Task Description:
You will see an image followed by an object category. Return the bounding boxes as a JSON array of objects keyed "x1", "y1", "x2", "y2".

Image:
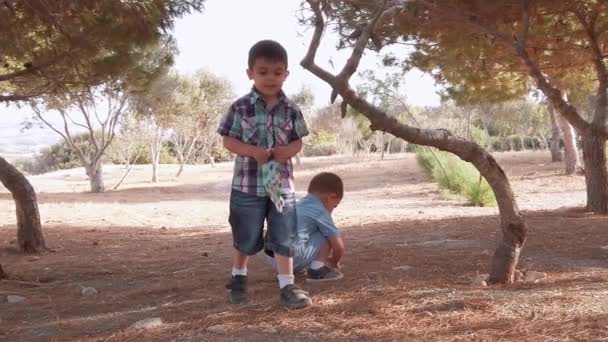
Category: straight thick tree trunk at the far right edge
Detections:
[{"x1": 583, "y1": 130, "x2": 608, "y2": 214}]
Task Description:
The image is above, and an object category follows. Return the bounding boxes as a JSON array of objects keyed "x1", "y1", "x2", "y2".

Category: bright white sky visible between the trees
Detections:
[{"x1": 0, "y1": 0, "x2": 439, "y2": 153}]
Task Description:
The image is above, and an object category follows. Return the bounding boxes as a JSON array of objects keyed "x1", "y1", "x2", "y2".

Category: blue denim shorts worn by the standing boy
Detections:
[{"x1": 229, "y1": 189, "x2": 296, "y2": 257}]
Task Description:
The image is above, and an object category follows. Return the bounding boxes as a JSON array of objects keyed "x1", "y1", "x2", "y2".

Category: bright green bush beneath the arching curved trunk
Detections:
[{"x1": 416, "y1": 148, "x2": 496, "y2": 207}]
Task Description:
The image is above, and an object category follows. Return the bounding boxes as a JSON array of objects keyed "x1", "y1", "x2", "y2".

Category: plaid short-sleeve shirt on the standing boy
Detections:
[{"x1": 217, "y1": 88, "x2": 308, "y2": 197}]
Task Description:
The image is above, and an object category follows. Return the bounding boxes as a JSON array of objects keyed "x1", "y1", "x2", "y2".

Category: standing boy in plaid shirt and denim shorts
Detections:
[{"x1": 218, "y1": 40, "x2": 312, "y2": 308}]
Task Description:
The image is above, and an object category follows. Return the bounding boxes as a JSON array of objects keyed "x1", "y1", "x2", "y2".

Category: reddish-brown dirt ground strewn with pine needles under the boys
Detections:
[{"x1": 0, "y1": 152, "x2": 608, "y2": 341}]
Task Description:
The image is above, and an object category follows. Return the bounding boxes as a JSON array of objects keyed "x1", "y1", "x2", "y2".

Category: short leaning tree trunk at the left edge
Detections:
[{"x1": 0, "y1": 157, "x2": 46, "y2": 253}]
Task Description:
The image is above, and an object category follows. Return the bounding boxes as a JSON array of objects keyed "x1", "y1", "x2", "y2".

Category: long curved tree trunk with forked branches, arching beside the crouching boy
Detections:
[{"x1": 300, "y1": 0, "x2": 527, "y2": 283}]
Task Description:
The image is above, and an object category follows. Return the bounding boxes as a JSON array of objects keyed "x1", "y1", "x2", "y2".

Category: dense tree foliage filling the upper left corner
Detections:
[{"x1": 0, "y1": 0, "x2": 204, "y2": 102}]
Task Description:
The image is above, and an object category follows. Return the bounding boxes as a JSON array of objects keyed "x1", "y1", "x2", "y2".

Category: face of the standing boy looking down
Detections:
[{"x1": 247, "y1": 58, "x2": 289, "y2": 98}]
